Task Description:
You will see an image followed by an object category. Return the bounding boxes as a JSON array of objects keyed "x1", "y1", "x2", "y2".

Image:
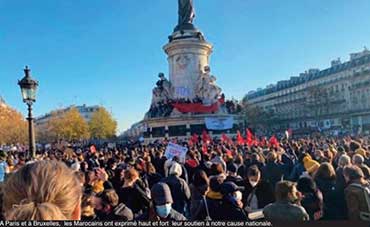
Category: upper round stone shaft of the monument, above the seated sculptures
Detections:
[{"x1": 163, "y1": 30, "x2": 212, "y2": 100}]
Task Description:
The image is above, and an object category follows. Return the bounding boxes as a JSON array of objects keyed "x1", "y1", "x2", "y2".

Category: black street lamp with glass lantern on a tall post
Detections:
[{"x1": 18, "y1": 66, "x2": 39, "y2": 158}]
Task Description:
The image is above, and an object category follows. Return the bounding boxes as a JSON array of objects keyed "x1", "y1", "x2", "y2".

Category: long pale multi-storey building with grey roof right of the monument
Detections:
[{"x1": 244, "y1": 48, "x2": 370, "y2": 133}]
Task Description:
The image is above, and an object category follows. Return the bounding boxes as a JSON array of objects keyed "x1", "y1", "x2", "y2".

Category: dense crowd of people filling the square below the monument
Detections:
[{"x1": 0, "y1": 137, "x2": 370, "y2": 222}]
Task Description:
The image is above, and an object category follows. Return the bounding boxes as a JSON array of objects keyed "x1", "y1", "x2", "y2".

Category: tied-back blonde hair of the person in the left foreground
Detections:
[{"x1": 3, "y1": 161, "x2": 82, "y2": 220}]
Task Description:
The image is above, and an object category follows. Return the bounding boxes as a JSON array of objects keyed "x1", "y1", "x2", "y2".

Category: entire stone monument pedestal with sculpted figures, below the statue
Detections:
[{"x1": 129, "y1": 23, "x2": 241, "y2": 143}]
